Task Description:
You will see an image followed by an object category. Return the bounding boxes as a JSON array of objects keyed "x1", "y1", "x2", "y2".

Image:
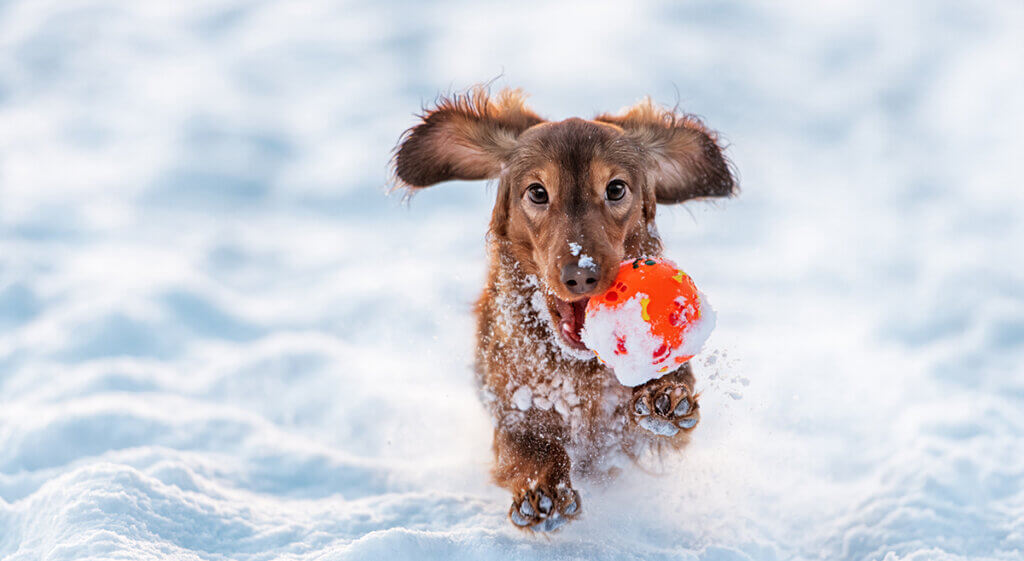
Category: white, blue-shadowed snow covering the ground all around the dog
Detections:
[{"x1": 0, "y1": 0, "x2": 1024, "y2": 561}]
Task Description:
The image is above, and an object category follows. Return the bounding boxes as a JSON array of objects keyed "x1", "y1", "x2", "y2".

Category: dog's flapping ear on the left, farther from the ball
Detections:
[{"x1": 393, "y1": 87, "x2": 544, "y2": 190}]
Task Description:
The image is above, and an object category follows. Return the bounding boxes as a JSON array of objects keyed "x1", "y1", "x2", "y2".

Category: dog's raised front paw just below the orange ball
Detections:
[{"x1": 630, "y1": 380, "x2": 700, "y2": 437}]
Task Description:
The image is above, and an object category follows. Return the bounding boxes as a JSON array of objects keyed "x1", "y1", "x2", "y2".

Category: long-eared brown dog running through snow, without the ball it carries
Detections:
[{"x1": 394, "y1": 88, "x2": 735, "y2": 531}]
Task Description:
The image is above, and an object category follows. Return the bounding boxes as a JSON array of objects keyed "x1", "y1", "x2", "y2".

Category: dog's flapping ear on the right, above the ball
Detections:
[{"x1": 595, "y1": 98, "x2": 737, "y2": 204}]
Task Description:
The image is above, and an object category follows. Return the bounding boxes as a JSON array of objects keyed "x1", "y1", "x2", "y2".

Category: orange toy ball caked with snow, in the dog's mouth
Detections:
[{"x1": 581, "y1": 259, "x2": 715, "y2": 386}]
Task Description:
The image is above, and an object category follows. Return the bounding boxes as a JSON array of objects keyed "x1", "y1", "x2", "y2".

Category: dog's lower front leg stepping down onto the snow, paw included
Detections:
[{"x1": 494, "y1": 428, "x2": 581, "y2": 531}]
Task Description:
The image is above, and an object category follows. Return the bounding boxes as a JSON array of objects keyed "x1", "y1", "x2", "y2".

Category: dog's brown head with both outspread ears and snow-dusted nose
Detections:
[{"x1": 394, "y1": 89, "x2": 735, "y2": 349}]
